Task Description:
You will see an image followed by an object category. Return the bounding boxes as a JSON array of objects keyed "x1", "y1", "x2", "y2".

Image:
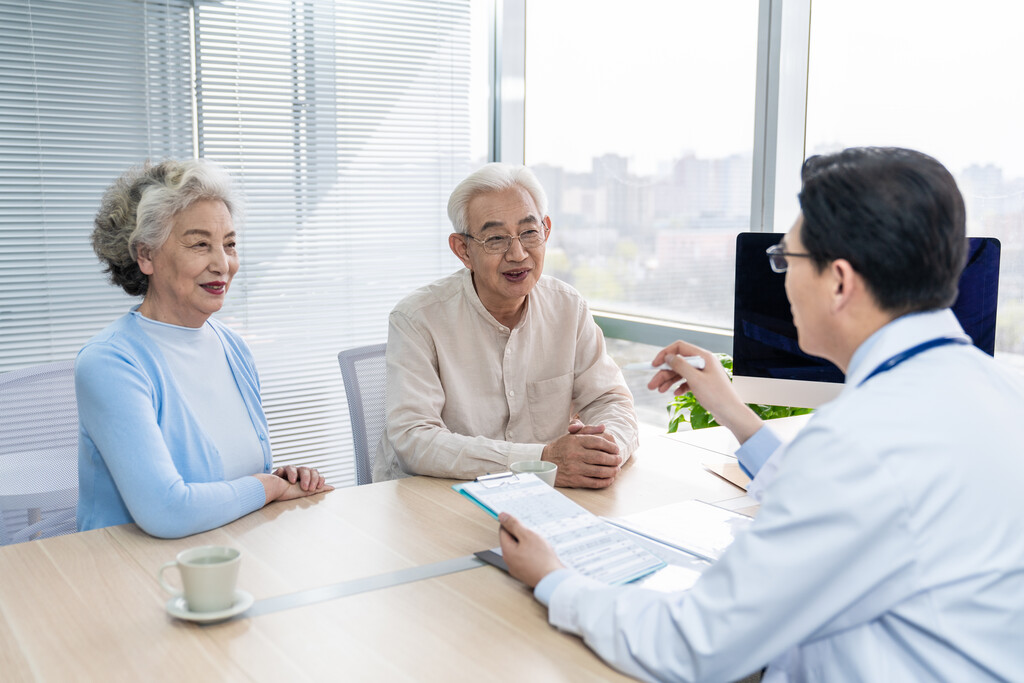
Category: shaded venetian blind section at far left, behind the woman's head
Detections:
[{"x1": 0, "y1": 0, "x2": 193, "y2": 372}]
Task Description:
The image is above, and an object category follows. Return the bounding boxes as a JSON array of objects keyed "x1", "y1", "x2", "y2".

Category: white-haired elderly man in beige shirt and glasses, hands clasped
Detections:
[{"x1": 374, "y1": 164, "x2": 637, "y2": 488}]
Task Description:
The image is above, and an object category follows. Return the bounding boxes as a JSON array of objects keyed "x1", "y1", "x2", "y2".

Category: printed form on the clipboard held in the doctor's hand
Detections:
[{"x1": 453, "y1": 472, "x2": 665, "y2": 585}]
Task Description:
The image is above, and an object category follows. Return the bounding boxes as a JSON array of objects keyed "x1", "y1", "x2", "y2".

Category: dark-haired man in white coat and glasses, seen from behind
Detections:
[{"x1": 500, "y1": 148, "x2": 1024, "y2": 681}]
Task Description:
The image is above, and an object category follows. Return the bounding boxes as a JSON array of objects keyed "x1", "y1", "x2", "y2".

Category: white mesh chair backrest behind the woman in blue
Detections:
[{"x1": 0, "y1": 360, "x2": 78, "y2": 544}]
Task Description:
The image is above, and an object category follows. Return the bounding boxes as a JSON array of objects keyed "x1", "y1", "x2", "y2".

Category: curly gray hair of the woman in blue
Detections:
[{"x1": 92, "y1": 159, "x2": 242, "y2": 296}]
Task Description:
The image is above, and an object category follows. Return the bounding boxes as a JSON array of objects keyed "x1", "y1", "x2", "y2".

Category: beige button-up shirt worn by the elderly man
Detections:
[{"x1": 374, "y1": 269, "x2": 637, "y2": 481}]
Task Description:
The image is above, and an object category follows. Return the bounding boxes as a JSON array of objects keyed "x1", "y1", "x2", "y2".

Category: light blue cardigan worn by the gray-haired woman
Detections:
[{"x1": 75, "y1": 306, "x2": 271, "y2": 539}]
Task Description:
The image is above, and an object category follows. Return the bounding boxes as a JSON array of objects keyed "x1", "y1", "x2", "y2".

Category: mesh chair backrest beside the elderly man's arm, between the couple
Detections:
[{"x1": 338, "y1": 344, "x2": 387, "y2": 484}]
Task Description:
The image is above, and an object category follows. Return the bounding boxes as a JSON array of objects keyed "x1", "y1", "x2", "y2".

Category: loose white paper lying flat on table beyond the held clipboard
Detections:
[{"x1": 608, "y1": 501, "x2": 753, "y2": 562}]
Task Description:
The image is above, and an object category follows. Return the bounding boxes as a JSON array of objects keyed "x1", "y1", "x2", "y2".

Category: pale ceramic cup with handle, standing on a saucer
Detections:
[{"x1": 157, "y1": 546, "x2": 242, "y2": 612}]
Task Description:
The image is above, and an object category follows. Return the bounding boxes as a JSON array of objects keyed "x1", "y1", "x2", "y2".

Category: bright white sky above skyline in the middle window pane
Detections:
[{"x1": 526, "y1": 0, "x2": 758, "y2": 173}]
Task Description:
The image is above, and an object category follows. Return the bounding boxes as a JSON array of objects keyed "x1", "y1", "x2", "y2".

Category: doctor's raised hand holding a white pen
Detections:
[{"x1": 647, "y1": 341, "x2": 764, "y2": 443}]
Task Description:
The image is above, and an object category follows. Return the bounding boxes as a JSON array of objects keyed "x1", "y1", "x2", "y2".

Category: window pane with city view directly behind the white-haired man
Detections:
[{"x1": 525, "y1": 0, "x2": 759, "y2": 328}]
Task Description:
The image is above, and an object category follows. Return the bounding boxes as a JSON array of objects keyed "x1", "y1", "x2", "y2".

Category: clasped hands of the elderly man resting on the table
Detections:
[{"x1": 541, "y1": 420, "x2": 623, "y2": 488}]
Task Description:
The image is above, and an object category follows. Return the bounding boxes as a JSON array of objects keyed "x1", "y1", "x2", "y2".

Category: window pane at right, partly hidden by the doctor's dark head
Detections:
[{"x1": 806, "y1": 0, "x2": 1024, "y2": 360}]
